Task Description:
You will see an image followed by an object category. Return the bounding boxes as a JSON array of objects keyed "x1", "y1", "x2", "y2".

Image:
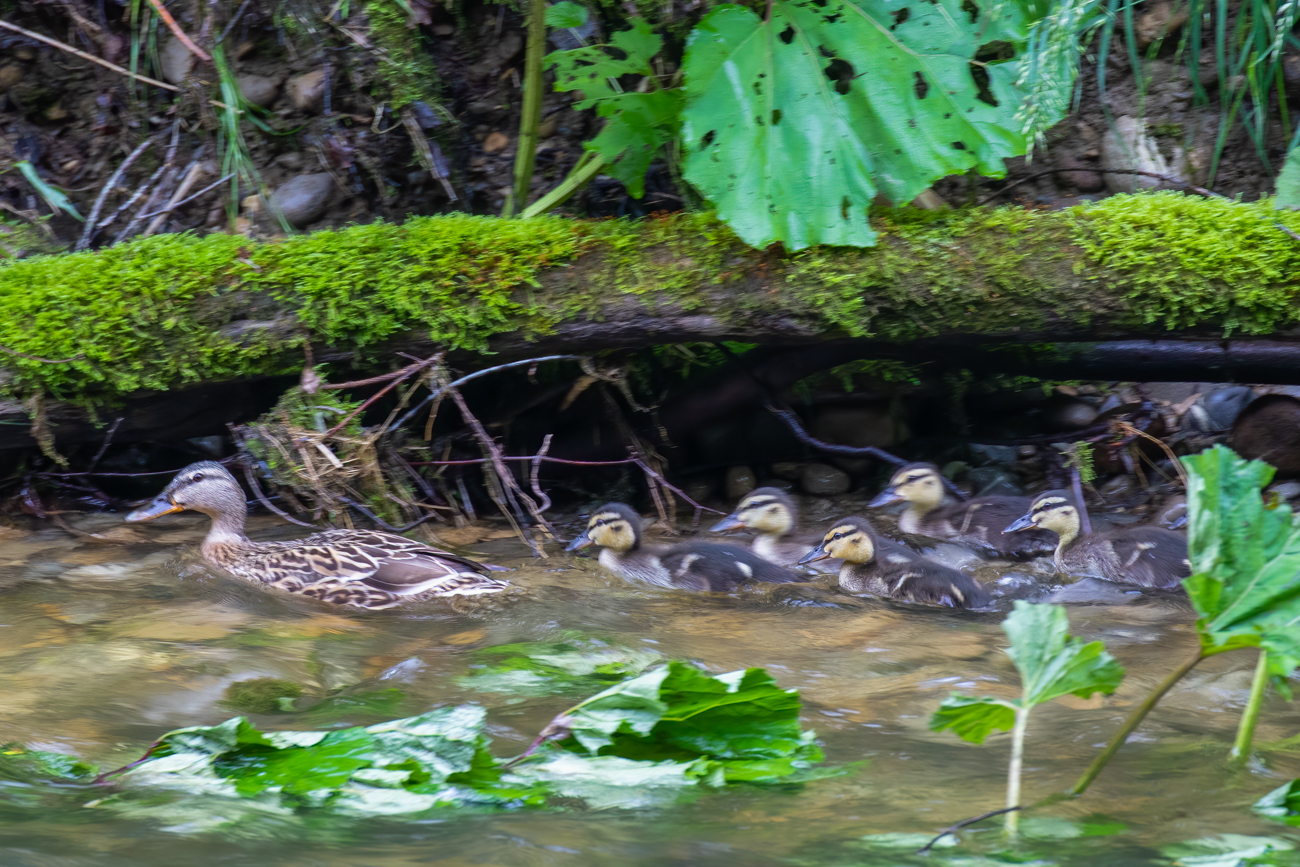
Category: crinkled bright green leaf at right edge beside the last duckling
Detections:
[{"x1": 1183, "y1": 446, "x2": 1300, "y2": 676}]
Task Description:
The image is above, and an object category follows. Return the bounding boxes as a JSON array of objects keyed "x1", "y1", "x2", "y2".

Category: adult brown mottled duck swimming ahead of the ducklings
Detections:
[{"x1": 126, "y1": 460, "x2": 510, "y2": 608}]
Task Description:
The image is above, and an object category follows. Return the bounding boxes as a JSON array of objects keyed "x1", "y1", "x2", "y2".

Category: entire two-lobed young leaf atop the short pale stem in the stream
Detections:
[{"x1": 930, "y1": 608, "x2": 1125, "y2": 744}]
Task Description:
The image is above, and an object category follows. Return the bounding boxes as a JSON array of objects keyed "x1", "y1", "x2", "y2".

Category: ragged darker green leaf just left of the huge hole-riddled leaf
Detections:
[{"x1": 546, "y1": 19, "x2": 681, "y2": 199}]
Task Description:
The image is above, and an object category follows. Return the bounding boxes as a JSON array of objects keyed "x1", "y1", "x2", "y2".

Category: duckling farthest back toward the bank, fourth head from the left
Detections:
[{"x1": 867, "y1": 463, "x2": 1056, "y2": 560}]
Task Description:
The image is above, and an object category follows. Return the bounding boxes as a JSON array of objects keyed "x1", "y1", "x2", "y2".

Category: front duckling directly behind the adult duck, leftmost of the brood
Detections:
[{"x1": 564, "y1": 503, "x2": 807, "y2": 591}]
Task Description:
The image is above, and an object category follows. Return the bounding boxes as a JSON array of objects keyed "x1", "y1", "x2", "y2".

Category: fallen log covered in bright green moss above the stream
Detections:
[{"x1": 0, "y1": 194, "x2": 1300, "y2": 445}]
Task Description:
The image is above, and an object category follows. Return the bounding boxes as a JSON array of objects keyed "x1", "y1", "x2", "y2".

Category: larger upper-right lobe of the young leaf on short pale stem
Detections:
[{"x1": 1002, "y1": 599, "x2": 1125, "y2": 707}]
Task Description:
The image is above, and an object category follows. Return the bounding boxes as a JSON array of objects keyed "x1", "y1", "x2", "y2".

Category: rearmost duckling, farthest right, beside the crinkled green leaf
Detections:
[{"x1": 1002, "y1": 490, "x2": 1192, "y2": 590}]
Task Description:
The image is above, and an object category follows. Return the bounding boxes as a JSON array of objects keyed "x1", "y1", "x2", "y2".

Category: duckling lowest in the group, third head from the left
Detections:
[{"x1": 800, "y1": 517, "x2": 989, "y2": 608}]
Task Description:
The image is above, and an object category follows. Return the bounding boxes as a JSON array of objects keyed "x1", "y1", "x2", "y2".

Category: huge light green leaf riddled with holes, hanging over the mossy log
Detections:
[{"x1": 681, "y1": 0, "x2": 1027, "y2": 250}]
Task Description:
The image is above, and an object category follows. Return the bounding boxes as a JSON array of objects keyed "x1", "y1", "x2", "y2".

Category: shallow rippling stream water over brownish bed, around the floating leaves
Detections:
[{"x1": 0, "y1": 515, "x2": 1300, "y2": 867}]
